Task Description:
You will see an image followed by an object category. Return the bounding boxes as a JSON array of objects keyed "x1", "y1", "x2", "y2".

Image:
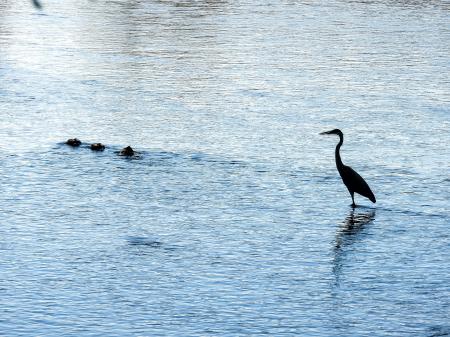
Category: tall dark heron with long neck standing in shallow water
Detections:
[{"x1": 321, "y1": 129, "x2": 376, "y2": 207}]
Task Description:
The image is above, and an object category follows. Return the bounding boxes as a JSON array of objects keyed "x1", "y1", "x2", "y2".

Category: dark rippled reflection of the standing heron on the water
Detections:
[{"x1": 333, "y1": 208, "x2": 375, "y2": 286}]
